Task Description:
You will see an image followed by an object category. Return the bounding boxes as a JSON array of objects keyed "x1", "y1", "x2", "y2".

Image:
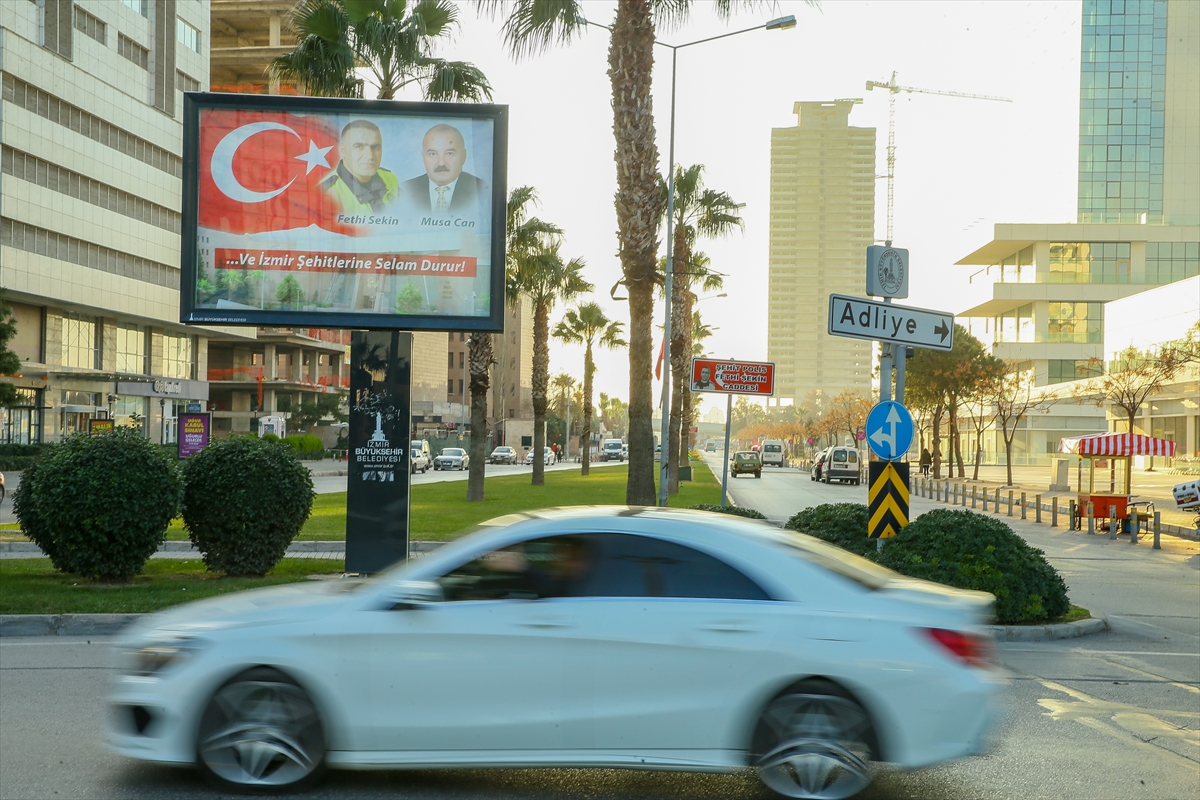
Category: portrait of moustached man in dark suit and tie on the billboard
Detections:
[{"x1": 403, "y1": 124, "x2": 491, "y2": 222}]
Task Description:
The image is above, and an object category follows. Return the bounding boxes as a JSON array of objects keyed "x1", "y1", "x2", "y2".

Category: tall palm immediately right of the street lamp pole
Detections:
[{"x1": 659, "y1": 164, "x2": 745, "y2": 493}]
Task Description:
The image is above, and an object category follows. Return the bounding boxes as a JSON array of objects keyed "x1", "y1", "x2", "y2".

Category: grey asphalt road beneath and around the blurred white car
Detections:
[{"x1": 0, "y1": 460, "x2": 1200, "y2": 800}]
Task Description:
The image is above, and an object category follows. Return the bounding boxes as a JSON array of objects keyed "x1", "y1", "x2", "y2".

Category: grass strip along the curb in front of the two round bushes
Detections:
[{"x1": 0, "y1": 559, "x2": 346, "y2": 614}]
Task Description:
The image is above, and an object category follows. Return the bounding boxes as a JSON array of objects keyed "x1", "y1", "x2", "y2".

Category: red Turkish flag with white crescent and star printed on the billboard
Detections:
[{"x1": 198, "y1": 109, "x2": 354, "y2": 234}]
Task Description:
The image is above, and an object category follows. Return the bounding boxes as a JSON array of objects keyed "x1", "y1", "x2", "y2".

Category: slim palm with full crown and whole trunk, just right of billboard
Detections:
[{"x1": 505, "y1": 236, "x2": 594, "y2": 486}]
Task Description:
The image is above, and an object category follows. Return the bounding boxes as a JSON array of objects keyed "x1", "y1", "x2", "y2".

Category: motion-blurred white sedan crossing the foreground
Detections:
[{"x1": 109, "y1": 506, "x2": 1004, "y2": 798}]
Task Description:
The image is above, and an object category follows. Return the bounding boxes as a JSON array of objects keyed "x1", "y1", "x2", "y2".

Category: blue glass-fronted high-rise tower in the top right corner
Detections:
[{"x1": 1079, "y1": 0, "x2": 1200, "y2": 225}]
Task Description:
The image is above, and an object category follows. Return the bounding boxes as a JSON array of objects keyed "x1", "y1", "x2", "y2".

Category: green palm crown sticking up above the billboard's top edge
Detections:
[{"x1": 269, "y1": 0, "x2": 492, "y2": 102}]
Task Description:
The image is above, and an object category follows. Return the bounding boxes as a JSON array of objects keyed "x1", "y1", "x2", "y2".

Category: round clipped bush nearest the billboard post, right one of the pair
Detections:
[{"x1": 182, "y1": 437, "x2": 314, "y2": 577}]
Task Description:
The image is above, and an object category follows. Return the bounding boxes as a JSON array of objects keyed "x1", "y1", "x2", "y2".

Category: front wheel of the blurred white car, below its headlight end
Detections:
[{"x1": 196, "y1": 667, "x2": 326, "y2": 793}]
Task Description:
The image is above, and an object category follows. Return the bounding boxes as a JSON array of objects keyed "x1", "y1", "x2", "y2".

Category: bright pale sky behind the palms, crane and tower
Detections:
[{"x1": 386, "y1": 0, "x2": 1081, "y2": 414}]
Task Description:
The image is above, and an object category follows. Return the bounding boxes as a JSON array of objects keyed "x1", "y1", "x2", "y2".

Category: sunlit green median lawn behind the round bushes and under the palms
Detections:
[{"x1": 158, "y1": 462, "x2": 721, "y2": 542}]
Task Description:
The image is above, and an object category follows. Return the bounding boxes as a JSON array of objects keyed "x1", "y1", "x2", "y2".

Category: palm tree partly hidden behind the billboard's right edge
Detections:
[{"x1": 467, "y1": 186, "x2": 563, "y2": 500}]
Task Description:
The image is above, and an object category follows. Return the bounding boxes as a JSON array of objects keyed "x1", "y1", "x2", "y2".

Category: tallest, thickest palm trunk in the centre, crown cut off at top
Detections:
[{"x1": 479, "y1": 0, "x2": 811, "y2": 505}]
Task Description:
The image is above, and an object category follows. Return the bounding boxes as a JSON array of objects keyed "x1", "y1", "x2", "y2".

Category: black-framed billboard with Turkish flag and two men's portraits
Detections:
[{"x1": 180, "y1": 92, "x2": 508, "y2": 331}]
